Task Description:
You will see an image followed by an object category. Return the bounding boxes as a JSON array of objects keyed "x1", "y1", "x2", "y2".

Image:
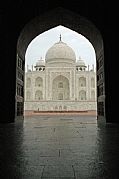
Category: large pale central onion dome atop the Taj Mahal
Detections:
[{"x1": 45, "y1": 37, "x2": 76, "y2": 63}]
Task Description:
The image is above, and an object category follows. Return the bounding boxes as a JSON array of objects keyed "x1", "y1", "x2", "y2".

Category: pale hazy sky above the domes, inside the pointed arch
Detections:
[{"x1": 25, "y1": 26, "x2": 96, "y2": 69}]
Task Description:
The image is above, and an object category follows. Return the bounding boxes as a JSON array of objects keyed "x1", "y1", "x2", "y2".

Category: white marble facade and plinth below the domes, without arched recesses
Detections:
[{"x1": 25, "y1": 66, "x2": 97, "y2": 111}]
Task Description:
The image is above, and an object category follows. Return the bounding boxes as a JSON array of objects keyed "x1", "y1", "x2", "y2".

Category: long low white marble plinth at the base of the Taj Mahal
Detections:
[{"x1": 24, "y1": 101, "x2": 97, "y2": 111}]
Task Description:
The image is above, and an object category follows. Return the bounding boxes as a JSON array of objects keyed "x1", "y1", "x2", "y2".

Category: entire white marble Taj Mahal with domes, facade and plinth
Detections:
[{"x1": 24, "y1": 36, "x2": 97, "y2": 111}]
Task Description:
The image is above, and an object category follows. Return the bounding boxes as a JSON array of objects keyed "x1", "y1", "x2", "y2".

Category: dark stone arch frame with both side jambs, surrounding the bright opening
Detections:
[{"x1": 16, "y1": 8, "x2": 106, "y2": 119}]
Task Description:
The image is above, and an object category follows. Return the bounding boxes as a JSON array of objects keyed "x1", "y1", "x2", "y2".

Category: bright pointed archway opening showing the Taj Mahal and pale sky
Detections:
[{"x1": 24, "y1": 25, "x2": 97, "y2": 117}]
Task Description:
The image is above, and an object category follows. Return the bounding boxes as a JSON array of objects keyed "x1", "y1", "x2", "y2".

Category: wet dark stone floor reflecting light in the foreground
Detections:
[{"x1": 0, "y1": 116, "x2": 119, "y2": 179}]
